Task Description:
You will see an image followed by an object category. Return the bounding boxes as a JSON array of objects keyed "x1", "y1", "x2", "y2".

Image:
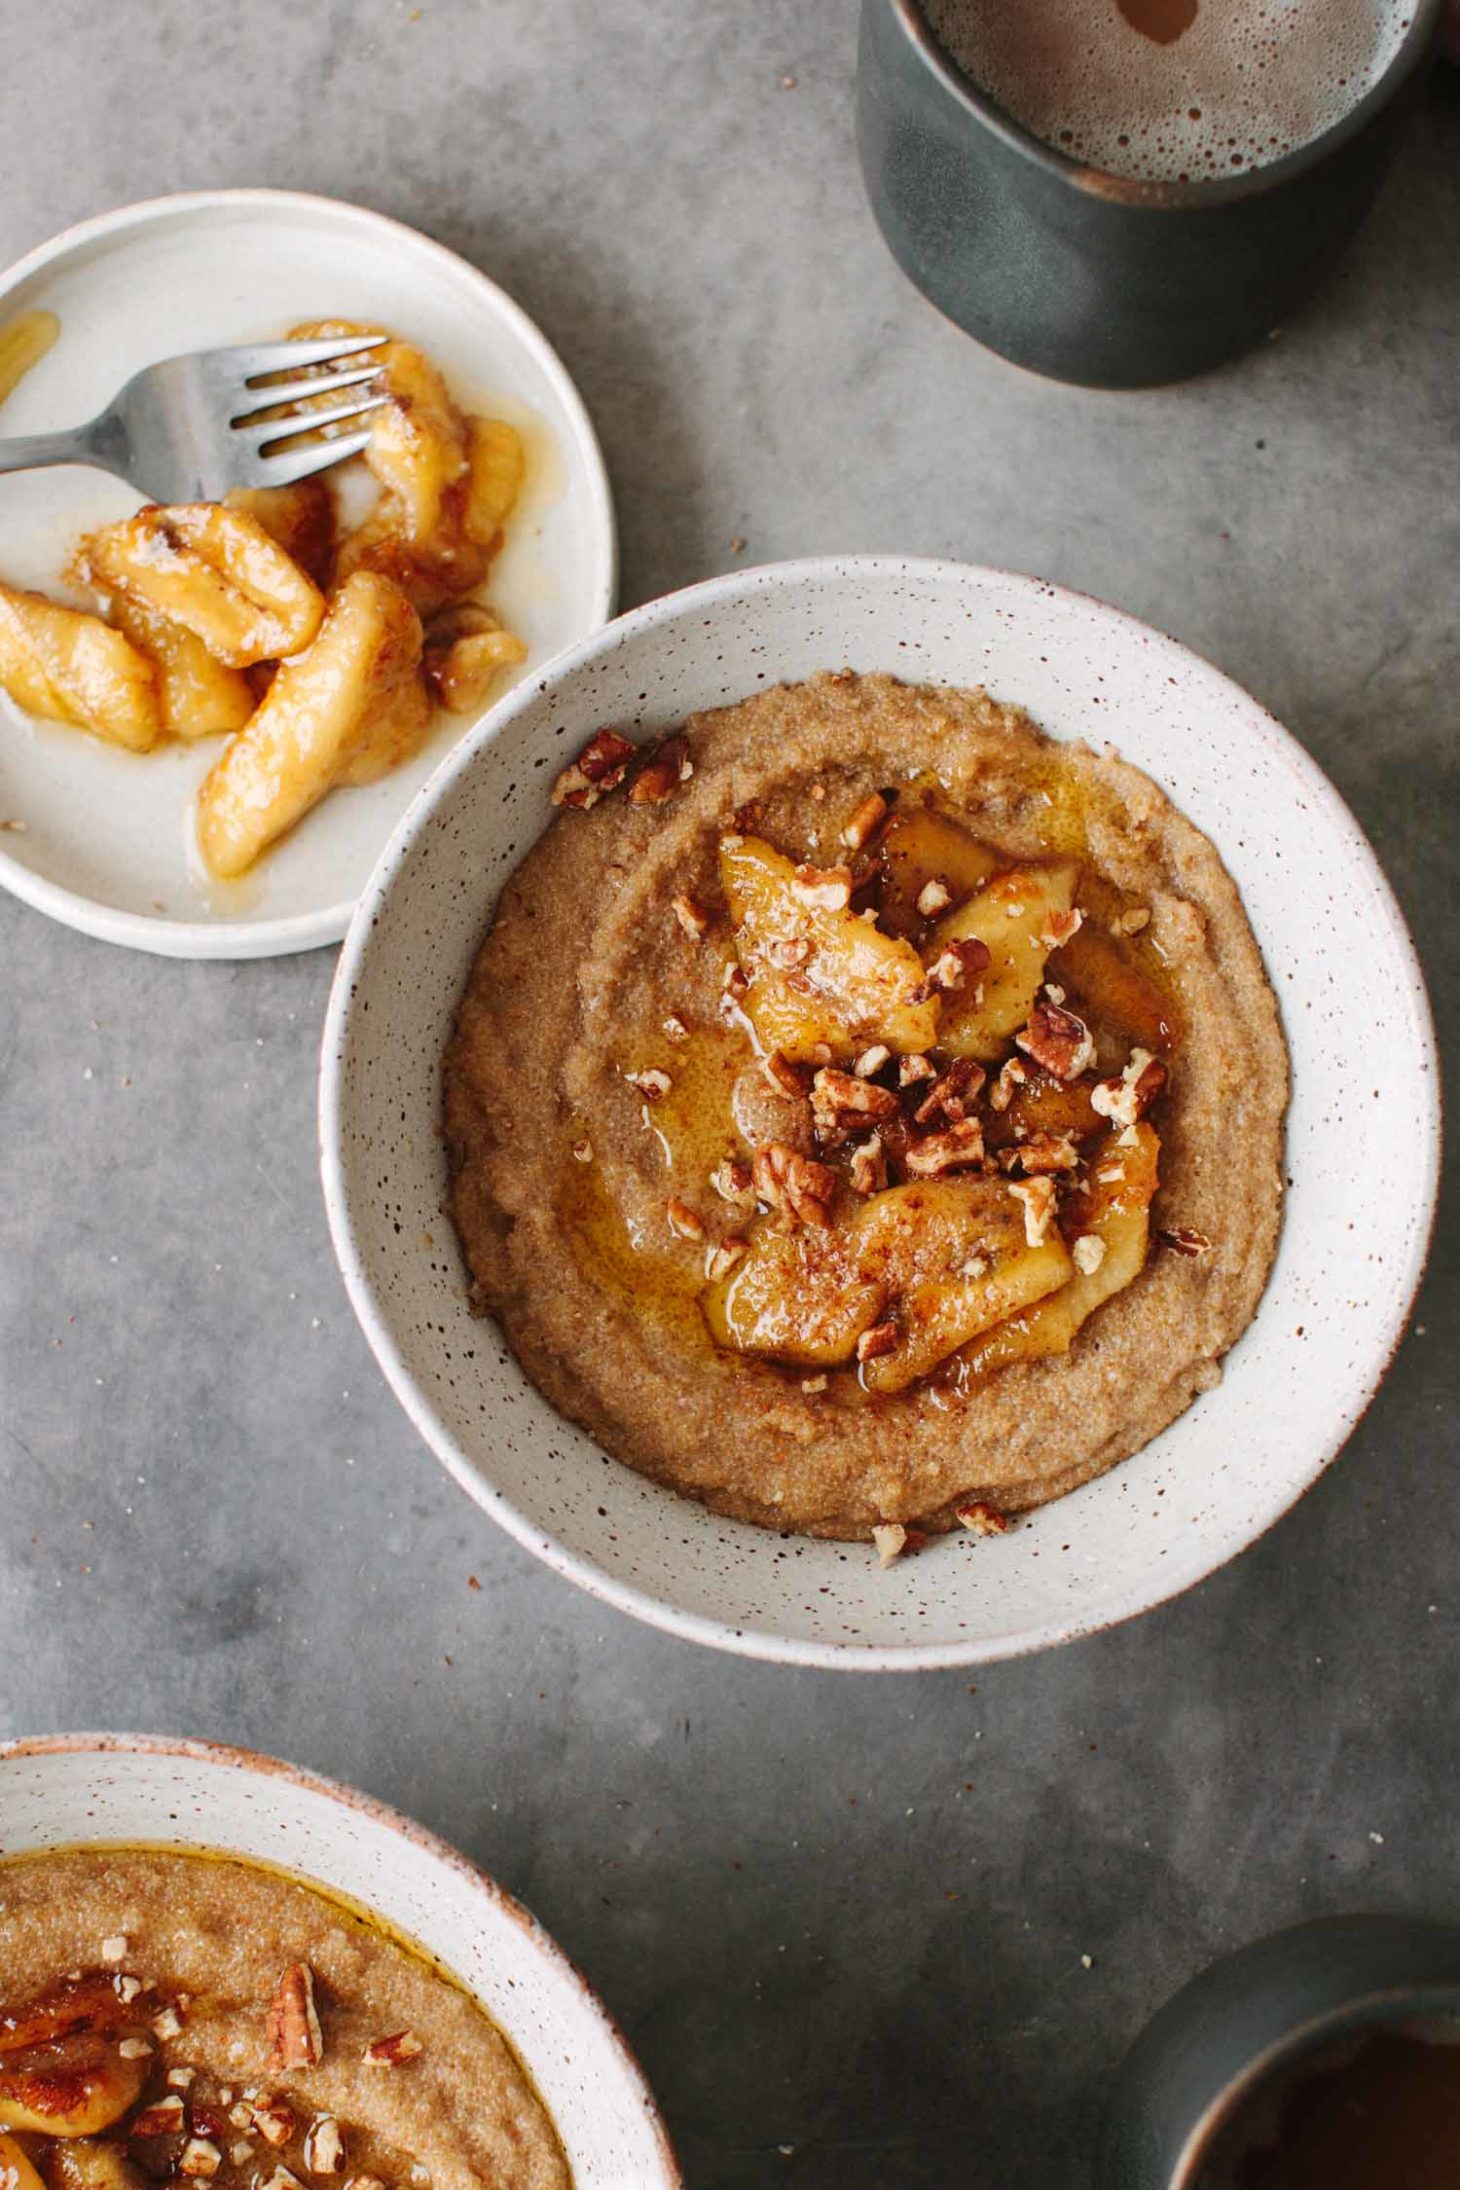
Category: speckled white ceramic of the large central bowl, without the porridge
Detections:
[{"x1": 320, "y1": 556, "x2": 1438, "y2": 1667}]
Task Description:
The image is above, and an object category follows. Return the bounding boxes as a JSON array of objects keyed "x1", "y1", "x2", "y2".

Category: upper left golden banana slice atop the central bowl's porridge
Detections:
[{"x1": 720, "y1": 837, "x2": 939, "y2": 1062}]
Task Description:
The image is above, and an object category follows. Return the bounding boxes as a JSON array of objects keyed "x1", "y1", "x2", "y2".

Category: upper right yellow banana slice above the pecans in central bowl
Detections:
[{"x1": 928, "y1": 858, "x2": 1079, "y2": 1062}]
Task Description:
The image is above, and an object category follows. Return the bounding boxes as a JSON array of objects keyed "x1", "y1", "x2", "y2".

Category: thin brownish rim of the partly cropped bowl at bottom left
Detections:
[{"x1": 0, "y1": 1732, "x2": 685, "y2": 2190}]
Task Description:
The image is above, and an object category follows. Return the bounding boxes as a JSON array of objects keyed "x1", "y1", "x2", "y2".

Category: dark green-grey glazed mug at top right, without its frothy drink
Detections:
[{"x1": 856, "y1": 0, "x2": 1440, "y2": 388}]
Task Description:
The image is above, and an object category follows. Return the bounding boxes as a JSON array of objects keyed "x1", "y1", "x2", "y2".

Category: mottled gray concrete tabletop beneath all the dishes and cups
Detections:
[{"x1": 0, "y1": 0, "x2": 1460, "y2": 2190}]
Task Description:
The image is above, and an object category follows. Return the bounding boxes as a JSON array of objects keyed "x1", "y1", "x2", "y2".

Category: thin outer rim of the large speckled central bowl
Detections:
[{"x1": 317, "y1": 554, "x2": 1440, "y2": 1673}]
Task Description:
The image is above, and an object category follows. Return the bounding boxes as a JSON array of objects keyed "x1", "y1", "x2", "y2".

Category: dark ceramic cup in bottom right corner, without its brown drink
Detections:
[{"x1": 1094, "y1": 1916, "x2": 1460, "y2": 2190}]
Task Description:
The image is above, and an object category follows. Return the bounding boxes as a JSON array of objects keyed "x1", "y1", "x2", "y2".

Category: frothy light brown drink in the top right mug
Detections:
[{"x1": 924, "y1": 0, "x2": 1412, "y2": 182}]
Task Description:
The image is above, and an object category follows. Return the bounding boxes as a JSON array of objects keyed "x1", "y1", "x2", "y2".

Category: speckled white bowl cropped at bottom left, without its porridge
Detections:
[{"x1": 0, "y1": 1734, "x2": 683, "y2": 2190}]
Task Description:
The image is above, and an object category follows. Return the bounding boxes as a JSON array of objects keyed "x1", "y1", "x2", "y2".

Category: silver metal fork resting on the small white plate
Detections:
[{"x1": 0, "y1": 335, "x2": 390, "y2": 502}]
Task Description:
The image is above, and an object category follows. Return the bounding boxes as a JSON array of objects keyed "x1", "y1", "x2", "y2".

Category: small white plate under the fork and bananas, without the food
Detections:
[{"x1": 0, "y1": 191, "x2": 617, "y2": 959}]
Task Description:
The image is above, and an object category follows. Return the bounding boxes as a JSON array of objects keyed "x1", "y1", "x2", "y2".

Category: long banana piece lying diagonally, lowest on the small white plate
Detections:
[{"x1": 197, "y1": 572, "x2": 420, "y2": 876}]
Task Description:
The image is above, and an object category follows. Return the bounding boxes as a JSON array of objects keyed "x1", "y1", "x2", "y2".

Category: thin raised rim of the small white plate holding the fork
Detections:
[{"x1": 0, "y1": 186, "x2": 619, "y2": 959}]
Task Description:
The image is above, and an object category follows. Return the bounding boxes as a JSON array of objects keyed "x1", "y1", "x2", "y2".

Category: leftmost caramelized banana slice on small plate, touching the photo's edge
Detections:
[{"x1": 0, "y1": 585, "x2": 162, "y2": 753}]
